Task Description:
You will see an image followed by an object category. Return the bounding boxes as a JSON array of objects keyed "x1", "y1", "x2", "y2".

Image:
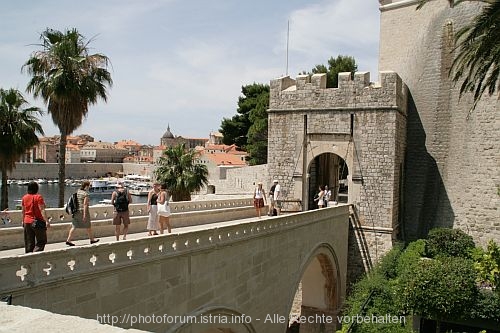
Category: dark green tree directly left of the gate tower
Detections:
[{"x1": 220, "y1": 83, "x2": 269, "y2": 164}]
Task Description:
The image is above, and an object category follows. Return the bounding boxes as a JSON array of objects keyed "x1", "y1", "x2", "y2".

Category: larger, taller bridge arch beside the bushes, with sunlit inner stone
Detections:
[{"x1": 287, "y1": 243, "x2": 342, "y2": 332}]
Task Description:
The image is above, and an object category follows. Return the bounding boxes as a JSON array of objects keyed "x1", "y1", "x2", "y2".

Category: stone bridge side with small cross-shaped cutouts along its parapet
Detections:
[{"x1": 0, "y1": 205, "x2": 350, "y2": 333}]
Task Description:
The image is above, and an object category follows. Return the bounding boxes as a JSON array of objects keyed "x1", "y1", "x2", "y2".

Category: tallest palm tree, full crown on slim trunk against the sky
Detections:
[{"x1": 23, "y1": 29, "x2": 113, "y2": 207}]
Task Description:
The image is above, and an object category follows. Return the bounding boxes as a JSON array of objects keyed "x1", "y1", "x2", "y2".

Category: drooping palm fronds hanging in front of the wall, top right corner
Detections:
[{"x1": 417, "y1": 0, "x2": 500, "y2": 111}]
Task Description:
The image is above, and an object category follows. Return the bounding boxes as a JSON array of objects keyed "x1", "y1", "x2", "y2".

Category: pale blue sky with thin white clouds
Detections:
[{"x1": 0, "y1": 0, "x2": 380, "y2": 145}]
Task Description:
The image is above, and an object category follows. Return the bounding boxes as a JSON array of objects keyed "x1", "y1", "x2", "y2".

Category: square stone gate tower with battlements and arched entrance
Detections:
[{"x1": 268, "y1": 72, "x2": 407, "y2": 269}]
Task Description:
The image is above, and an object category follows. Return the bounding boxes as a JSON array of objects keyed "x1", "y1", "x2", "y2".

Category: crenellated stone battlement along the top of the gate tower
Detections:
[{"x1": 270, "y1": 71, "x2": 407, "y2": 111}]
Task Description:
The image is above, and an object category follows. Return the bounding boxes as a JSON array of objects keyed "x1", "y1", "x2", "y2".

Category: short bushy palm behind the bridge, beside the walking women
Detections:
[{"x1": 155, "y1": 144, "x2": 208, "y2": 201}]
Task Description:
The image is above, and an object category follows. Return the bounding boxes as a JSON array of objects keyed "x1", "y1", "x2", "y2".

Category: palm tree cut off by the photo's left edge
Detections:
[{"x1": 0, "y1": 89, "x2": 43, "y2": 210}]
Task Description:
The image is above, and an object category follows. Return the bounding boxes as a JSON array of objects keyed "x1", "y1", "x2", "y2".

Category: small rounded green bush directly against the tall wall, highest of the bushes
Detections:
[{"x1": 426, "y1": 228, "x2": 475, "y2": 258}]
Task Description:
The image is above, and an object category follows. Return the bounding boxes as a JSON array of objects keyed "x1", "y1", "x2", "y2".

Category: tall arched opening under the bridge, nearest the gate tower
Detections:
[{"x1": 287, "y1": 245, "x2": 340, "y2": 333}]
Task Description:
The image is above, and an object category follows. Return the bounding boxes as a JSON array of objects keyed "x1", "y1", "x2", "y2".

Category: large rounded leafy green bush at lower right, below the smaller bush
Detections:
[{"x1": 399, "y1": 257, "x2": 478, "y2": 320}]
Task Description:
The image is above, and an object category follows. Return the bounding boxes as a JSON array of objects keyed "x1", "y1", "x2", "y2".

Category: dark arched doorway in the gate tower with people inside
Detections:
[{"x1": 307, "y1": 152, "x2": 349, "y2": 209}]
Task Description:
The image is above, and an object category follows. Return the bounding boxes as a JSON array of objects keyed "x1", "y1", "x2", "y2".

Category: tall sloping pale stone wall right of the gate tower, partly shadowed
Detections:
[{"x1": 379, "y1": 0, "x2": 500, "y2": 245}]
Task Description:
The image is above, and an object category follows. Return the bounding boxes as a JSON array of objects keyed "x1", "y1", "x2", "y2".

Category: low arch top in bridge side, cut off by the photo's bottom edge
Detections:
[{"x1": 172, "y1": 306, "x2": 257, "y2": 333}]
